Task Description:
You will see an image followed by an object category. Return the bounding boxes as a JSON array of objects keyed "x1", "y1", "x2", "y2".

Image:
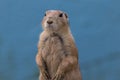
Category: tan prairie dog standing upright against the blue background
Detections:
[{"x1": 36, "y1": 10, "x2": 82, "y2": 80}]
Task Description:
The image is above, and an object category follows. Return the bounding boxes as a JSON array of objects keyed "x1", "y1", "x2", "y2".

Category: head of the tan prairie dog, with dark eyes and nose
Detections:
[{"x1": 42, "y1": 10, "x2": 68, "y2": 32}]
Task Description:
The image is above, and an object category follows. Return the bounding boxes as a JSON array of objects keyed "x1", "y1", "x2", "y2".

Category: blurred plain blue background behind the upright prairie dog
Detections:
[{"x1": 0, "y1": 0, "x2": 120, "y2": 80}]
